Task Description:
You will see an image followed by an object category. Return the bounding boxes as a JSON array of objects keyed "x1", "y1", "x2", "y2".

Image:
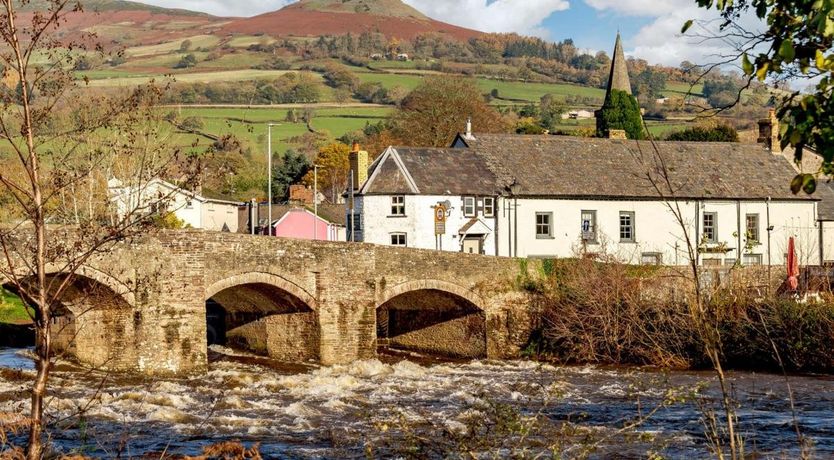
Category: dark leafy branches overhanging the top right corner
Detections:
[{"x1": 682, "y1": 0, "x2": 834, "y2": 193}]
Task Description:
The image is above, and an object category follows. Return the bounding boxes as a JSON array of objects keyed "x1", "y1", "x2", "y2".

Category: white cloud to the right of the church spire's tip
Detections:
[{"x1": 585, "y1": 0, "x2": 761, "y2": 66}]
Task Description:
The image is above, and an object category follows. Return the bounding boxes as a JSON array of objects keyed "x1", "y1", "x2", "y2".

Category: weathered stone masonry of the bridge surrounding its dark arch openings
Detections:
[{"x1": 26, "y1": 230, "x2": 540, "y2": 375}]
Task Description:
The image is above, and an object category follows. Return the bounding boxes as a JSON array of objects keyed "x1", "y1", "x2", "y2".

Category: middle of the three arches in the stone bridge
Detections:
[{"x1": 205, "y1": 272, "x2": 320, "y2": 362}]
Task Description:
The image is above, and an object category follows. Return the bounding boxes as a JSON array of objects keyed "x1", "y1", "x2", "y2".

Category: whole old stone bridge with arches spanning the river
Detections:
[{"x1": 3, "y1": 230, "x2": 538, "y2": 375}]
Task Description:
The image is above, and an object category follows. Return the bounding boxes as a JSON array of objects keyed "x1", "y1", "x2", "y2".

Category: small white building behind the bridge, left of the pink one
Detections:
[{"x1": 109, "y1": 179, "x2": 243, "y2": 232}]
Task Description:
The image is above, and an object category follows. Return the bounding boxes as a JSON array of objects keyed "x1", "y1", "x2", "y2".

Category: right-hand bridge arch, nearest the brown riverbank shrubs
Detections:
[{"x1": 376, "y1": 279, "x2": 487, "y2": 358}]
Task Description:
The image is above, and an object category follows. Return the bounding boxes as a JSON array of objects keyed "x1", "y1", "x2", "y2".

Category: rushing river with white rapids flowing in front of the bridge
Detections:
[{"x1": 0, "y1": 347, "x2": 834, "y2": 458}]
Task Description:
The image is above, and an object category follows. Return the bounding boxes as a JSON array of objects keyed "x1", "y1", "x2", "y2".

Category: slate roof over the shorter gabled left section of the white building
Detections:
[{"x1": 360, "y1": 147, "x2": 498, "y2": 196}]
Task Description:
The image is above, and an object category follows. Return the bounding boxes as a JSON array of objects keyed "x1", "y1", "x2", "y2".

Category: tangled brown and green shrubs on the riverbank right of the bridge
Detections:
[{"x1": 520, "y1": 260, "x2": 834, "y2": 373}]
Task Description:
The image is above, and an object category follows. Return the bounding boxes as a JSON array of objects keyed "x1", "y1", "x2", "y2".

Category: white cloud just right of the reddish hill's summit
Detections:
[{"x1": 403, "y1": 0, "x2": 570, "y2": 37}]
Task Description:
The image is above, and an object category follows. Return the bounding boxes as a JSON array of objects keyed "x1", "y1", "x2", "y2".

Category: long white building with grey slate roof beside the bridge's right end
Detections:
[{"x1": 356, "y1": 133, "x2": 820, "y2": 265}]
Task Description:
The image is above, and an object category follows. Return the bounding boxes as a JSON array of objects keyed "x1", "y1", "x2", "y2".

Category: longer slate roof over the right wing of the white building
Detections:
[{"x1": 458, "y1": 134, "x2": 817, "y2": 200}]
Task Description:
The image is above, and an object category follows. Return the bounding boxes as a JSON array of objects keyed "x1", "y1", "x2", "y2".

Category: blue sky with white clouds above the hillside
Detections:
[{"x1": 141, "y1": 0, "x2": 758, "y2": 66}]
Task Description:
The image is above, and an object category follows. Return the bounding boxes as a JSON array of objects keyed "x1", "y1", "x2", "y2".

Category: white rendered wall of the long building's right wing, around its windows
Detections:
[{"x1": 498, "y1": 198, "x2": 812, "y2": 265}]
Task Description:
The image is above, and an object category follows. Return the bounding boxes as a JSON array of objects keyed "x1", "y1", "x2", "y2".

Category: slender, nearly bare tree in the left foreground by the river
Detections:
[{"x1": 0, "y1": 0, "x2": 193, "y2": 460}]
